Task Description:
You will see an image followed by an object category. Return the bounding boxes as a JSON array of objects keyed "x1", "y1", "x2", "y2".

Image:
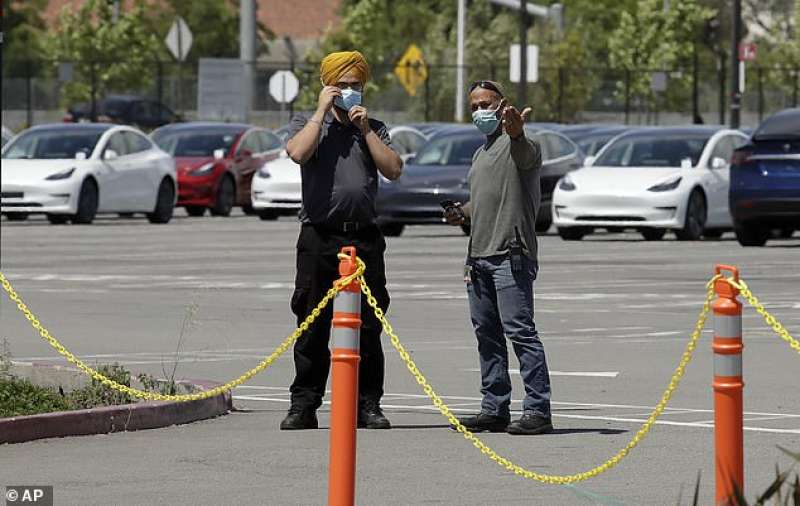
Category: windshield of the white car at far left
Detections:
[{"x1": 3, "y1": 129, "x2": 105, "y2": 160}]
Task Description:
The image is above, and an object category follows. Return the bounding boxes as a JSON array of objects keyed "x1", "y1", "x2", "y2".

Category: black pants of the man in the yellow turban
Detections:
[{"x1": 290, "y1": 224, "x2": 389, "y2": 409}]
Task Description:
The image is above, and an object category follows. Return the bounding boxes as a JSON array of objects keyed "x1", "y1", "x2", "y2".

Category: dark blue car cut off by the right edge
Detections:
[{"x1": 729, "y1": 108, "x2": 800, "y2": 246}]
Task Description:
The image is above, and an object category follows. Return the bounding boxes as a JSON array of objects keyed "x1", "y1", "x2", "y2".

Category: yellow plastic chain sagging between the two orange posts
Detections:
[{"x1": 359, "y1": 259, "x2": 720, "y2": 485}]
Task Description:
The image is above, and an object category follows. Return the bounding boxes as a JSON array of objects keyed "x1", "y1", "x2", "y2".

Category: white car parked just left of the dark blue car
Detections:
[{"x1": 553, "y1": 127, "x2": 748, "y2": 241}]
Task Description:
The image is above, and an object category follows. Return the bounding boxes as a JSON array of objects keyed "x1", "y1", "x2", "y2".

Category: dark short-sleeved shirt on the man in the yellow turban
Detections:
[{"x1": 288, "y1": 112, "x2": 392, "y2": 226}]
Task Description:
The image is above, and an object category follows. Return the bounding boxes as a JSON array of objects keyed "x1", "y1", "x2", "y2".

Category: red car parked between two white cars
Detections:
[{"x1": 151, "y1": 122, "x2": 283, "y2": 216}]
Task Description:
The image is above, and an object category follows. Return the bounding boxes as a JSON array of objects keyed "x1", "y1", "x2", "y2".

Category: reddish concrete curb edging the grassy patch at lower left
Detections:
[{"x1": 0, "y1": 372, "x2": 233, "y2": 444}]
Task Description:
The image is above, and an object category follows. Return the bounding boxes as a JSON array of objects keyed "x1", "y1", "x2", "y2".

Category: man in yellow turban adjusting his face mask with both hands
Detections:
[{"x1": 281, "y1": 51, "x2": 403, "y2": 430}]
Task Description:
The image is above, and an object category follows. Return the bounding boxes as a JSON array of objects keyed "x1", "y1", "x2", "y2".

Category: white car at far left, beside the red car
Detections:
[{"x1": 0, "y1": 123, "x2": 177, "y2": 224}]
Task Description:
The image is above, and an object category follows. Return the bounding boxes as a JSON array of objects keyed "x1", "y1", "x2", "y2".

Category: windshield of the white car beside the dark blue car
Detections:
[{"x1": 594, "y1": 131, "x2": 711, "y2": 167}]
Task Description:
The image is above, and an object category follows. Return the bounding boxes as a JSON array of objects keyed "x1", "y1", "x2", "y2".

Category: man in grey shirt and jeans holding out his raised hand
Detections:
[{"x1": 445, "y1": 81, "x2": 553, "y2": 434}]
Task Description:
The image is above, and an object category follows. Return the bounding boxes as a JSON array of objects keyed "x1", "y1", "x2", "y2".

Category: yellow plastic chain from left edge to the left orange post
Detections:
[{"x1": 0, "y1": 262, "x2": 365, "y2": 402}]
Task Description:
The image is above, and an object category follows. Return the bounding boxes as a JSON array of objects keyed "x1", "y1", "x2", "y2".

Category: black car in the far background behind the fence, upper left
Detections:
[{"x1": 64, "y1": 95, "x2": 182, "y2": 130}]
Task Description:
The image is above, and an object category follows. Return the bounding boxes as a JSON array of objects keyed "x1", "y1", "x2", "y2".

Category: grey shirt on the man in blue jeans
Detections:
[{"x1": 469, "y1": 133, "x2": 542, "y2": 261}]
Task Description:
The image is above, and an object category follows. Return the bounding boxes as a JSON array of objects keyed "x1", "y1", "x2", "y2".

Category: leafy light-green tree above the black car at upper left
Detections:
[{"x1": 47, "y1": 0, "x2": 164, "y2": 102}]
